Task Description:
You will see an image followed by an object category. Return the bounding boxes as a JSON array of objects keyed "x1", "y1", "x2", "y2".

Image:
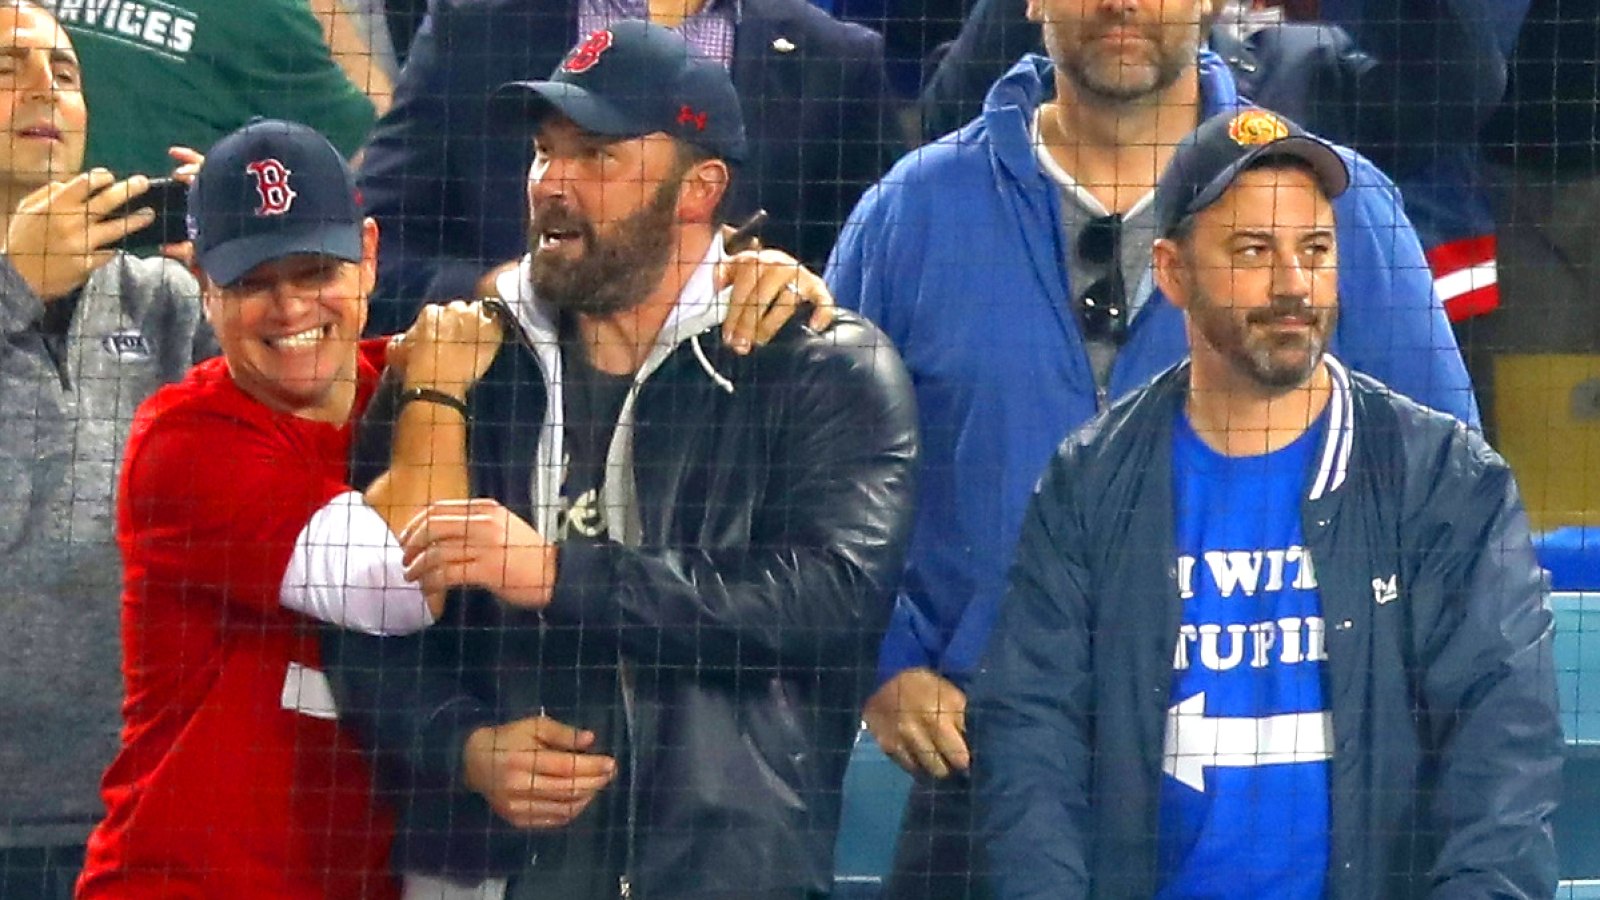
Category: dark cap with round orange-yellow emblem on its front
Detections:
[{"x1": 1155, "y1": 106, "x2": 1350, "y2": 237}]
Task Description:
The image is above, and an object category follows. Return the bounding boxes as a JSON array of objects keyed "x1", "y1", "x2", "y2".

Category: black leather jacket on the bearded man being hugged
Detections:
[{"x1": 325, "y1": 277, "x2": 917, "y2": 898}]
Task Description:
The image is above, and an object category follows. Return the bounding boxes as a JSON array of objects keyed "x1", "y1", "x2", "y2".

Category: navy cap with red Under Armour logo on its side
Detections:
[{"x1": 491, "y1": 19, "x2": 746, "y2": 162}]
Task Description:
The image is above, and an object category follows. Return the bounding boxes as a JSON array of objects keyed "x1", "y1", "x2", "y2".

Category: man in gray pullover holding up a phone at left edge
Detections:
[{"x1": 0, "y1": 0, "x2": 211, "y2": 898}]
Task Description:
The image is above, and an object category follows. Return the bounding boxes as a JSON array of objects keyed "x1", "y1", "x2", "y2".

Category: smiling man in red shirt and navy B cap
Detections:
[{"x1": 78, "y1": 120, "x2": 499, "y2": 900}]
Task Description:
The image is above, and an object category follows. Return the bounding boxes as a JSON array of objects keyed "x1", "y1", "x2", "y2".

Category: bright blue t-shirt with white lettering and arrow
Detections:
[{"x1": 1157, "y1": 413, "x2": 1331, "y2": 900}]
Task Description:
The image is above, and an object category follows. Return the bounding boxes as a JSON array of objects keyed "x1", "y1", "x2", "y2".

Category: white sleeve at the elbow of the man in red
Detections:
[{"x1": 278, "y1": 490, "x2": 434, "y2": 634}]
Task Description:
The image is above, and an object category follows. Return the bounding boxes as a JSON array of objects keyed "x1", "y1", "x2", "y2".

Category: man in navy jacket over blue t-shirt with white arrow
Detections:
[{"x1": 971, "y1": 110, "x2": 1562, "y2": 900}]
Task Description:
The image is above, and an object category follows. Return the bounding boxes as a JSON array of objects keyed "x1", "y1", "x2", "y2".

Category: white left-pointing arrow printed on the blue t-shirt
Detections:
[{"x1": 1162, "y1": 693, "x2": 1333, "y2": 793}]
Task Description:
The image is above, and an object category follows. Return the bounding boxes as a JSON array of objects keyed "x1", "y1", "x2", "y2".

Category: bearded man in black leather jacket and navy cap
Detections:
[{"x1": 326, "y1": 22, "x2": 917, "y2": 900}]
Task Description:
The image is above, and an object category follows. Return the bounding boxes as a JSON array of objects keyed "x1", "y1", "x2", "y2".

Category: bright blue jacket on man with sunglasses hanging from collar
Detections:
[{"x1": 827, "y1": 51, "x2": 1477, "y2": 687}]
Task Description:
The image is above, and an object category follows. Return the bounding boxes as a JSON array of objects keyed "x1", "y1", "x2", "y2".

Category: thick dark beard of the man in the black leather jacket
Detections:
[{"x1": 528, "y1": 179, "x2": 680, "y2": 315}]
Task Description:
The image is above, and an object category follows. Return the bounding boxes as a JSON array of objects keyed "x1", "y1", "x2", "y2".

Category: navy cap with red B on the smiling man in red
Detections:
[{"x1": 189, "y1": 119, "x2": 362, "y2": 285}]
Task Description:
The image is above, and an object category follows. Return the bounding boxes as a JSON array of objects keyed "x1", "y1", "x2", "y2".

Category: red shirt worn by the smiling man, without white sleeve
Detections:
[{"x1": 78, "y1": 343, "x2": 398, "y2": 900}]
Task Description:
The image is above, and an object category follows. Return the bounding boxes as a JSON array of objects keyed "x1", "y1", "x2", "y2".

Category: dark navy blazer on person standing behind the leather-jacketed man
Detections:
[{"x1": 360, "y1": 0, "x2": 899, "y2": 333}]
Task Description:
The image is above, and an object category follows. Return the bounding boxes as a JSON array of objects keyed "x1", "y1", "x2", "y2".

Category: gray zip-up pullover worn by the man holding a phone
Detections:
[{"x1": 0, "y1": 255, "x2": 214, "y2": 847}]
